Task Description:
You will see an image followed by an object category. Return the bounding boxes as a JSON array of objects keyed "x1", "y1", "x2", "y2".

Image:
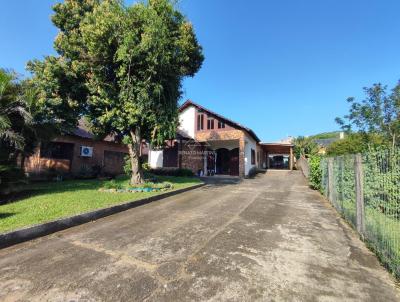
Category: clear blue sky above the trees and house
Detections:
[{"x1": 0, "y1": 0, "x2": 400, "y2": 141}]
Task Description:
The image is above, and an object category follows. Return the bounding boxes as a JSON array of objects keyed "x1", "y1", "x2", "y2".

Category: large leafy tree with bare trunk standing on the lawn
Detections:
[{"x1": 32, "y1": 0, "x2": 203, "y2": 184}]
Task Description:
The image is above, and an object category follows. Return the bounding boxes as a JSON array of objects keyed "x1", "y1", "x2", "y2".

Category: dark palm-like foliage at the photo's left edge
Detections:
[{"x1": 0, "y1": 69, "x2": 57, "y2": 190}]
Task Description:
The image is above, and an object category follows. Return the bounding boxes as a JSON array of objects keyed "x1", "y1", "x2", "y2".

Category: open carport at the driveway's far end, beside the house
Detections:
[{"x1": 260, "y1": 143, "x2": 294, "y2": 170}]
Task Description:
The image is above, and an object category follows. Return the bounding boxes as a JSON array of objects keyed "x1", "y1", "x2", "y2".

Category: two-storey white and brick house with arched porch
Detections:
[{"x1": 149, "y1": 100, "x2": 286, "y2": 177}]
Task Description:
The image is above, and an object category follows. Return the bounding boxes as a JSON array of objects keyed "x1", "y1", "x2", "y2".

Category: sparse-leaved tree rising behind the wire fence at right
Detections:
[{"x1": 336, "y1": 83, "x2": 400, "y2": 147}]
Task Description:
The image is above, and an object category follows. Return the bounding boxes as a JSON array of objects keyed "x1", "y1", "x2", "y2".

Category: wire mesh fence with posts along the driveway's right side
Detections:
[{"x1": 321, "y1": 149, "x2": 400, "y2": 278}]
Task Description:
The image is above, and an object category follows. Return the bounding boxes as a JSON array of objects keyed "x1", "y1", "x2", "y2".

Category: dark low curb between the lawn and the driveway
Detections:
[{"x1": 0, "y1": 183, "x2": 205, "y2": 249}]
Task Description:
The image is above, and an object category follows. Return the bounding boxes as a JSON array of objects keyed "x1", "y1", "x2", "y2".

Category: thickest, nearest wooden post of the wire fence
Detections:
[{"x1": 354, "y1": 154, "x2": 365, "y2": 236}]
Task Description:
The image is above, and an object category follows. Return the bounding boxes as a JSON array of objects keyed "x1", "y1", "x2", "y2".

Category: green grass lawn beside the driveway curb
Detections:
[{"x1": 0, "y1": 176, "x2": 201, "y2": 233}]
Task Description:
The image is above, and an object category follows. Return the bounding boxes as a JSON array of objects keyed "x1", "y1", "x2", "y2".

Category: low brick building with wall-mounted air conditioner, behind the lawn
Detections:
[{"x1": 23, "y1": 120, "x2": 146, "y2": 178}]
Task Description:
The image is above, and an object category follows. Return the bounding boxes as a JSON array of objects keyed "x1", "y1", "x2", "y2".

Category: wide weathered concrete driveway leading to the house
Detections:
[{"x1": 0, "y1": 171, "x2": 400, "y2": 301}]
